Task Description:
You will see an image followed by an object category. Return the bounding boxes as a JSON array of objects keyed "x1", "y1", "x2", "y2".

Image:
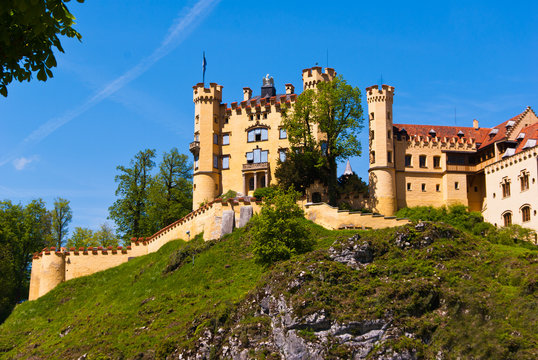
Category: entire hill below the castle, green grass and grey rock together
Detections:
[{"x1": 0, "y1": 224, "x2": 538, "y2": 359}]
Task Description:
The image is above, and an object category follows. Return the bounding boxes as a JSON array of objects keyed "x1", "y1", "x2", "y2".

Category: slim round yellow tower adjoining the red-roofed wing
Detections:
[{"x1": 366, "y1": 85, "x2": 397, "y2": 216}]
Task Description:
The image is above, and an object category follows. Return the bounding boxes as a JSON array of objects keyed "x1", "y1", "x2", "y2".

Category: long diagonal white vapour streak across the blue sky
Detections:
[{"x1": 0, "y1": 0, "x2": 220, "y2": 166}]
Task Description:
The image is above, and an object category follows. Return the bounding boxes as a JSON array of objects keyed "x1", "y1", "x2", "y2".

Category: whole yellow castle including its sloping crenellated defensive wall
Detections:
[{"x1": 29, "y1": 67, "x2": 538, "y2": 300}]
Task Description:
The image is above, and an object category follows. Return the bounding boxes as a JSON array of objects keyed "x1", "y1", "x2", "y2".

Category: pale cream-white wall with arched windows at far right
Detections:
[{"x1": 483, "y1": 147, "x2": 538, "y2": 232}]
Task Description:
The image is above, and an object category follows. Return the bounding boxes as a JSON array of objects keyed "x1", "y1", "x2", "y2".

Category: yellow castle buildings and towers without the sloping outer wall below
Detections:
[{"x1": 190, "y1": 66, "x2": 538, "y2": 230}]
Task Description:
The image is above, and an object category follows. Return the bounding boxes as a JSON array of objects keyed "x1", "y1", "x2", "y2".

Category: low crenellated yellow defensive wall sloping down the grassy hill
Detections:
[{"x1": 28, "y1": 197, "x2": 408, "y2": 300}]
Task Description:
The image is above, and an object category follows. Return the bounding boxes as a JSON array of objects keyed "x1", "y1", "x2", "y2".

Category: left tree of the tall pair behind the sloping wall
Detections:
[{"x1": 108, "y1": 149, "x2": 155, "y2": 243}]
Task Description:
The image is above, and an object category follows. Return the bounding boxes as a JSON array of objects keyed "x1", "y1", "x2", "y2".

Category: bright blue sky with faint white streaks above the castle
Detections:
[{"x1": 0, "y1": 0, "x2": 538, "y2": 233}]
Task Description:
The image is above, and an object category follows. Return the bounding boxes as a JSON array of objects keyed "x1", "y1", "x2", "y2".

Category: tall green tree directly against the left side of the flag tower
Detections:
[{"x1": 148, "y1": 148, "x2": 192, "y2": 232}]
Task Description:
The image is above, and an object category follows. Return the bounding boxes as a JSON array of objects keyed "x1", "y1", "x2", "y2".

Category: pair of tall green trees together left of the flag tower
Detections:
[{"x1": 108, "y1": 148, "x2": 192, "y2": 243}]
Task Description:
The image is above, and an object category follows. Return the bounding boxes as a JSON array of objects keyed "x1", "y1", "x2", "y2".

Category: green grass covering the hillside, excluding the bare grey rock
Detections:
[{"x1": 0, "y1": 224, "x2": 538, "y2": 359}]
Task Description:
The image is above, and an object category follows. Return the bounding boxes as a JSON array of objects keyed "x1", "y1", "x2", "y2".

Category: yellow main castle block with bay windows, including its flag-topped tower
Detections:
[{"x1": 190, "y1": 66, "x2": 336, "y2": 209}]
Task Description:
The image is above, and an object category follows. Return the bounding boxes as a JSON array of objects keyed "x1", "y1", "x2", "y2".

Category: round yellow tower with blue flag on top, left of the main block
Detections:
[{"x1": 189, "y1": 83, "x2": 222, "y2": 209}]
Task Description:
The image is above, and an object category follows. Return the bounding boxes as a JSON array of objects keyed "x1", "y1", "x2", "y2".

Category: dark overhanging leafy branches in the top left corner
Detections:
[{"x1": 0, "y1": 0, "x2": 84, "y2": 96}]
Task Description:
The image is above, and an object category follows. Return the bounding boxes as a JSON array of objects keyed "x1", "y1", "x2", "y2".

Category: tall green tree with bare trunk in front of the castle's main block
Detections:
[{"x1": 283, "y1": 75, "x2": 364, "y2": 204}]
